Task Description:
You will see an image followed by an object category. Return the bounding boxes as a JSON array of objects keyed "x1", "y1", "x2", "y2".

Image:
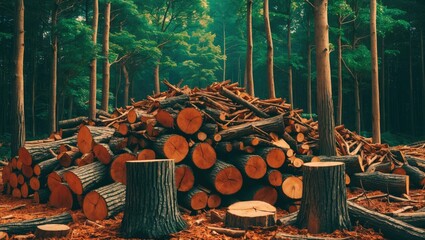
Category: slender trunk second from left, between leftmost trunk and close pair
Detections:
[{"x1": 49, "y1": 0, "x2": 59, "y2": 133}]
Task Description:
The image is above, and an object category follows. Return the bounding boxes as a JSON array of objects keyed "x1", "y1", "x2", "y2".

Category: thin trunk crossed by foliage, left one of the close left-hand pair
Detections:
[{"x1": 89, "y1": 0, "x2": 99, "y2": 119}]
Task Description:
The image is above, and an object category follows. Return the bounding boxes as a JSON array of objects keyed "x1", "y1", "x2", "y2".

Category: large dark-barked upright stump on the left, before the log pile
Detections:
[{"x1": 121, "y1": 159, "x2": 186, "y2": 238}]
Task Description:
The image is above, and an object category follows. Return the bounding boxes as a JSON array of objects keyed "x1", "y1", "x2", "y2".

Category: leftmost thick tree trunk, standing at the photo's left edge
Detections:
[{"x1": 10, "y1": 0, "x2": 25, "y2": 156}]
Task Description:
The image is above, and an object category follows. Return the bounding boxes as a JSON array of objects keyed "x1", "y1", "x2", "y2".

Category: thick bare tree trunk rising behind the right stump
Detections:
[{"x1": 314, "y1": 0, "x2": 336, "y2": 156}]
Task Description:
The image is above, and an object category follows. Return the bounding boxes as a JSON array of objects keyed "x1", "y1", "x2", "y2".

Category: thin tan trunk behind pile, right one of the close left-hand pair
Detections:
[{"x1": 102, "y1": 2, "x2": 111, "y2": 111}]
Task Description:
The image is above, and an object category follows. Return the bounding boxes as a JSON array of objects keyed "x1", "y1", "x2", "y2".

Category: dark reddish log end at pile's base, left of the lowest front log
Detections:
[{"x1": 49, "y1": 183, "x2": 79, "y2": 210}]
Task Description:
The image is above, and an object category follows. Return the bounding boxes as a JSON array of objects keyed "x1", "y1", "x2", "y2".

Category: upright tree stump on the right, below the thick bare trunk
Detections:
[{"x1": 297, "y1": 162, "x2": 351, "y2": 233}]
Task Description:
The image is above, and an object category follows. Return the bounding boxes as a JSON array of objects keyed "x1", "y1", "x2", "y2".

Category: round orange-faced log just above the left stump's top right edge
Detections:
[{"x1": 154, "y1": 134, "x2": 189, "y2": 163}]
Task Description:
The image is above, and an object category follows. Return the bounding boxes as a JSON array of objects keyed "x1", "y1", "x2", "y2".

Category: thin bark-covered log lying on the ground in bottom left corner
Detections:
[{"x1": 0, "y1": 212, "x2": 73, "y2": 234}]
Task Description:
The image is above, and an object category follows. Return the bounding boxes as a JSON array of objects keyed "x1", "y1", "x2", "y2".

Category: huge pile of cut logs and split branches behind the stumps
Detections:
[{"x1": 2, "y1": 81, "x2": 425, "y2": 220}]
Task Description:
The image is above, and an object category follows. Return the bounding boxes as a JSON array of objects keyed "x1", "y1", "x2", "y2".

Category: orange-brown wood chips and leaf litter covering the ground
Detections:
[{"x1": 0, "y1": 169, "x2": 425, "y2": 240}]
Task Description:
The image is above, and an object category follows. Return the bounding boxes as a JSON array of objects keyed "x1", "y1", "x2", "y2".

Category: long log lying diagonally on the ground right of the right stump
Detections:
[{"x1": 347, "y1": 201, "x2": 425, "y2": 240}]
